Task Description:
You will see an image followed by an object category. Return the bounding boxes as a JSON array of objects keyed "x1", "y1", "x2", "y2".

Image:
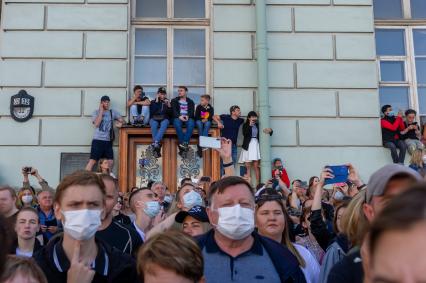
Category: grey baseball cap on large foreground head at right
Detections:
[{"x1": 366, "y1": 164, "x2": 422, "y2": 203}]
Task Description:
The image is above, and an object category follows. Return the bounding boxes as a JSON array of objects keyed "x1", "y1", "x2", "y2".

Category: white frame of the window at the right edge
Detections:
[{"x1": 375, "y1": 24, "x2": 426, "y2": 117}]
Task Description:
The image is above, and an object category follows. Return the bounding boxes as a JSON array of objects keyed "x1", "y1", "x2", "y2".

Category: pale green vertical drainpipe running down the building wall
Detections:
[{"x1": 256, "y1": 0, "x2": 271, "y2": 182}]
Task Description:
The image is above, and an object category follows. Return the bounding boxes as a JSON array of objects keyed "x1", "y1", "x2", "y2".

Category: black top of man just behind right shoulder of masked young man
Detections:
[{"x1": 96, "y1": 221, "x2": 143, "y2": 256}]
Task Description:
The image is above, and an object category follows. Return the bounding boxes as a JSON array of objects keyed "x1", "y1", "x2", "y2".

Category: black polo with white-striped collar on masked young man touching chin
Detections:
[{"x1": 33, "y1": 235, "x2": 140, "y2": 283}]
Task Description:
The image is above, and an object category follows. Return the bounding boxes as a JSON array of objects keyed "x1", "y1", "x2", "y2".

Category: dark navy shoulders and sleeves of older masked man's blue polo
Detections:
[{"x1": 195, "y1": 229, "x2": 306, "y2": 283}]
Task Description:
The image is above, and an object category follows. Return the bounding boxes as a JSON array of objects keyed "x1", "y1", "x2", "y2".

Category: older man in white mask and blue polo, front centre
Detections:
[{"x1": 197, "y1": 176, "x2": 306, "y2": 282}]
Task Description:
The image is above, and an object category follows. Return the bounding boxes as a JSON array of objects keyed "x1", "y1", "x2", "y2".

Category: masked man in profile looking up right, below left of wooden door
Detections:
[{"x1": 129, "y1": 188, "x2": 162, "y2": 242}]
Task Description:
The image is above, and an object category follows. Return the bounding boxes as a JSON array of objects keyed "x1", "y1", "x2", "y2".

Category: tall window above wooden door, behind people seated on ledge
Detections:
[{"x1": 132, "y1": 0, "x2": 210, "y2": 103}]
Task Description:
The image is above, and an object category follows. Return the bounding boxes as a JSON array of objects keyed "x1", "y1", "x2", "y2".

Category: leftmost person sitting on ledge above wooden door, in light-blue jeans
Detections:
[{"x1": 127, "y1": 85, "x2": 150, "y2": 125}]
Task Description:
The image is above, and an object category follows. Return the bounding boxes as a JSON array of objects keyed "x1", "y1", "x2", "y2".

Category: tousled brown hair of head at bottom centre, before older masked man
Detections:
[{"x1": 137, "y1": 230, "x2": 204, "y2": 282}]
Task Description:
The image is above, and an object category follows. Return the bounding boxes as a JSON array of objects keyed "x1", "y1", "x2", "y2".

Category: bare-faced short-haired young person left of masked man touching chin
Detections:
[{"x1": 12, "y1": 207, "x2": 42, "y2": 257}]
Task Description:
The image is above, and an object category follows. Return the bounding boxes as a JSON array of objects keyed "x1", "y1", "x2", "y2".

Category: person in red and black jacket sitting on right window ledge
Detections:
[{"x1": 380, "y1": 105, "x2": 407, "y2": 164}]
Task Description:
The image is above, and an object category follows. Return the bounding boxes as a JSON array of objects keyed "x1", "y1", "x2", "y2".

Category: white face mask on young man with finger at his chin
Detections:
[{"x1": 62, "y1": 209, "x2": 102, "y2": 241}]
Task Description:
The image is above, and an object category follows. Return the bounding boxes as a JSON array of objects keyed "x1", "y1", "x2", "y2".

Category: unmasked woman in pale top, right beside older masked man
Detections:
[{"x1": 255, "y1": 189, "x2": 320, "y2": 283}]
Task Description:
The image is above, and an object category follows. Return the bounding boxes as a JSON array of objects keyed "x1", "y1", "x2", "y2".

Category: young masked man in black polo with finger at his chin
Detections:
[{"x1": 34, "y1": 171, "x2": 138, "y2": 283}]
